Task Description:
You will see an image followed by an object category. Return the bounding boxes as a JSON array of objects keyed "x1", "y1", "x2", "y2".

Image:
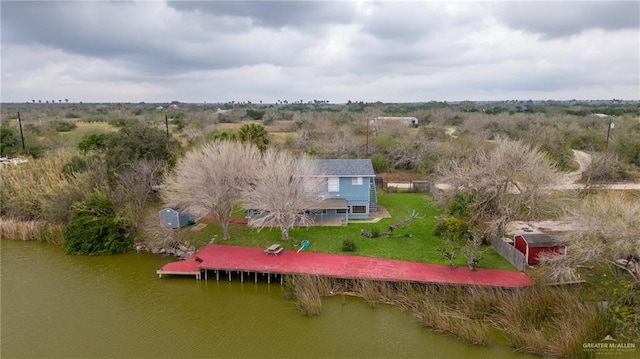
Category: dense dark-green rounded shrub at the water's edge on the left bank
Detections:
[{"x1": 64, "y1": 194, "x2": 132, "y2": 255}]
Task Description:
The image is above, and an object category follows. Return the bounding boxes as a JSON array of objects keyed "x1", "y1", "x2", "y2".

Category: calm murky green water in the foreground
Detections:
[{"x1": 0, "y1": 241, "x2": 536, "y2": 358}]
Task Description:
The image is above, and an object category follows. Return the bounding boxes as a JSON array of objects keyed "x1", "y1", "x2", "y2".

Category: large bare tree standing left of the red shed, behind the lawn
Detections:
[{"x1": 437, "y1": 137, "x2": 560, "y2": 236}]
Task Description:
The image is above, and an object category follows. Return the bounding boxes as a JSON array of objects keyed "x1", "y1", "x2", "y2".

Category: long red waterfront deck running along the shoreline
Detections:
[{"x1": 162, "y1": 244, "x2": 535, "y2": 288}]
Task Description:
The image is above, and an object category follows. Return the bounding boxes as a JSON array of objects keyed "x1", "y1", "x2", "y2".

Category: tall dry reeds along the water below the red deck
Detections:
[{"x1": 287, "y1": 275, "x2": 607, "y2": 358}]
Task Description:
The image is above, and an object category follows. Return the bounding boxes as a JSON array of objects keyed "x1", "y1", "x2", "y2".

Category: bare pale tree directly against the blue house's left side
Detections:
[{"x1": 245, "y1": 149, "x2": 324, "y2": 240}]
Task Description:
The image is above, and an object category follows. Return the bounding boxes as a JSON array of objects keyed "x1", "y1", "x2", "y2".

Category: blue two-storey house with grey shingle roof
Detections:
[{"x1": 310, "y1": 159, "x2": 378, "y2": 223}]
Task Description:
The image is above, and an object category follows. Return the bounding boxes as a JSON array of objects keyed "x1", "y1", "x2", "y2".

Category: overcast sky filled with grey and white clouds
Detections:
[{"x1": 0, "y1": 0, "x2": 640, "y2": 103}]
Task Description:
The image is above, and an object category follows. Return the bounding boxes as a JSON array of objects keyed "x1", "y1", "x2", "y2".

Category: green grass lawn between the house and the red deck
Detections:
[{"x1": 181, "y1": 193, "x2": 515, "y2": 270}]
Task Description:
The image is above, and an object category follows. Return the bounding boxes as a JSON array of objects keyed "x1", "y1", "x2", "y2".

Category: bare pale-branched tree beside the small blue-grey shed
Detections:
[{"x1": 161, "y1": 141, "x2": 260, "y2": 239}]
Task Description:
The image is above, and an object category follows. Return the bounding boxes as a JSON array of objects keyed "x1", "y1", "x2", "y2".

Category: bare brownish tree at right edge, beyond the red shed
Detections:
[{"x1": 540, "y1": 192, "x2": 640, "y2": 281}]
